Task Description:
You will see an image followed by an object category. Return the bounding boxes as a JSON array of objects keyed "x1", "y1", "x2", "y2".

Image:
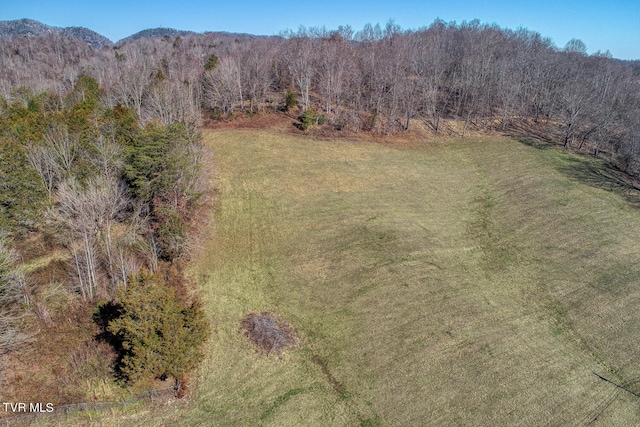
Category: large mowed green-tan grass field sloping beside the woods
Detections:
[{"x1": 57, "y1": 130, "x2": 640, "y2": 426}]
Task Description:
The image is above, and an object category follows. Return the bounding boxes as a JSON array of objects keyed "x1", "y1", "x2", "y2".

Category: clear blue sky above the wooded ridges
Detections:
[{"x1": 0, "y1": 0, "x2": 640, "y2": 59}]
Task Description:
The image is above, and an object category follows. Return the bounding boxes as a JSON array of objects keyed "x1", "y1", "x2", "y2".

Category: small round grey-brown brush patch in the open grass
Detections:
[{"x1": 242, "y1": 312, "x2": 298, "y2": 355}]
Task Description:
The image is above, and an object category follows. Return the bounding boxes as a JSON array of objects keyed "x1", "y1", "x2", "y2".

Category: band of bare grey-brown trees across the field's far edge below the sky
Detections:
[{"x1": 0, "y1": 20, "x2": 640, "y2": 175}]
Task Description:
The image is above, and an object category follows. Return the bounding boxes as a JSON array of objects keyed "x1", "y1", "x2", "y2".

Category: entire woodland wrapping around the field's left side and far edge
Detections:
[{"x1": 0, "y1": 17, "x2": 640, "y2": 418}]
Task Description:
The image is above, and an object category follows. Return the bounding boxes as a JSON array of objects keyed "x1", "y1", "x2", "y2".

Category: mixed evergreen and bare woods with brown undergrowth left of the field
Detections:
[{"x1": 0, "y1": 74, "x2": 208, "y2": 406}]
